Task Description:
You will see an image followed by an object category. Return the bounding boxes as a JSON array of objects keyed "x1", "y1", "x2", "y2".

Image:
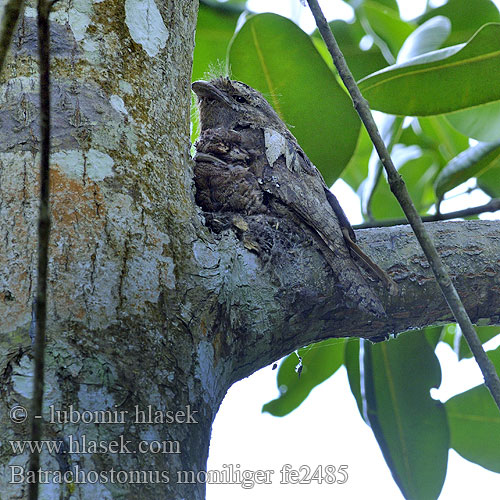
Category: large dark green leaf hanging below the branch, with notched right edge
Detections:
[{"x1": 361, "y1": 332, "x2": 449, "y2": 500}]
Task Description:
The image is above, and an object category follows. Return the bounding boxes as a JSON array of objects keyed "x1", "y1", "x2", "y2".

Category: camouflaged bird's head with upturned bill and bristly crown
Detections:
[{"x1": 192, "y1": 77, "x2": 286, "y2": 133}]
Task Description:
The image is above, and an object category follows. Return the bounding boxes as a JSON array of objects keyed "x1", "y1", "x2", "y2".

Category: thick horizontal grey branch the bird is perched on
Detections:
[{"x1": 189, "y1": 220, "x2": 500, "y2": 382}]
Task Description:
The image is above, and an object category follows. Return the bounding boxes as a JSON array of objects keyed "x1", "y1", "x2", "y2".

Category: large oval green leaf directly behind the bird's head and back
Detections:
[{"x1": 229, "y1": 14, "x2": 360, "y2": 185}]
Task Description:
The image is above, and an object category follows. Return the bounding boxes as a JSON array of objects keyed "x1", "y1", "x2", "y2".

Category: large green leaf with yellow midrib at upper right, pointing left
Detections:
[{"x1": 359, "y1": 24, "x2": 500, "y2": 116}]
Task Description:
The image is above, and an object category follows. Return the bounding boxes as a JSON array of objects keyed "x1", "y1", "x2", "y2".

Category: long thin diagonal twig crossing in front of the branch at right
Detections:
[{"x1": 307, "y1": 0, "x2": 500, "y2": 409}]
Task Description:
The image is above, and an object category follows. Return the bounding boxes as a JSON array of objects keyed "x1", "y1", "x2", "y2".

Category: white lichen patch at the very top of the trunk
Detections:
[{"x1": 125, "y1": 0, "x2": 168, "y2": 57}]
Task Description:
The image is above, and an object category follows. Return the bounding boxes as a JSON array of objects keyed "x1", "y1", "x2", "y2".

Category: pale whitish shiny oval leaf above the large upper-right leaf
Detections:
[{"x1": 397, "y1": 16, "x2": 451, "y2": 64}]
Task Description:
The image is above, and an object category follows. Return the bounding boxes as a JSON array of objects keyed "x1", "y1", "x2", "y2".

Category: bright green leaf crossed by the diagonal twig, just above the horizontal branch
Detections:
[{"x1": 371, "y1": 151, "x2": 438, "y2": 219}]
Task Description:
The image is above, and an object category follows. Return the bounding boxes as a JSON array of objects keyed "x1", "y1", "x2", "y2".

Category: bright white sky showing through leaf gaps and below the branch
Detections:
[{"x1": 207, "y1": 0, "x2": 500, "y2": 500}]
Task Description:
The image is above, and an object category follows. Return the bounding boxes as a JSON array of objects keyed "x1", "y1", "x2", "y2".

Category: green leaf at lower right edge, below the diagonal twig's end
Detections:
[{"x1": 445, "y1": 347, "x2": 500, "y2": 472}]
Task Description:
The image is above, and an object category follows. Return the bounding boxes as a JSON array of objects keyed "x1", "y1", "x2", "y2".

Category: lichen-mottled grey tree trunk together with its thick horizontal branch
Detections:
[{"x1": 0, "y1": 0, "x2": 500, "y2": 500}]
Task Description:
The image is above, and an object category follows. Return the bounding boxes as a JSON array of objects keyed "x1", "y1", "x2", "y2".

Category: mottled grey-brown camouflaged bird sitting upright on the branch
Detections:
[{"x1": 192, "y1": 78, "x2": 396, "y2": 315}]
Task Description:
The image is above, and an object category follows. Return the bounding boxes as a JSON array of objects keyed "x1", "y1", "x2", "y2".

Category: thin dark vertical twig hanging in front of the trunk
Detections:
[{"x1": 28, "y1": 0, "x2": 50, "y2": 500}]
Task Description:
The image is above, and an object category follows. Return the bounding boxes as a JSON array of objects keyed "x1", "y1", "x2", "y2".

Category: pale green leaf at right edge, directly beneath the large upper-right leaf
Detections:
[{"x1": 445, "y1": 101, "x2": 500, "y2": 142}]
